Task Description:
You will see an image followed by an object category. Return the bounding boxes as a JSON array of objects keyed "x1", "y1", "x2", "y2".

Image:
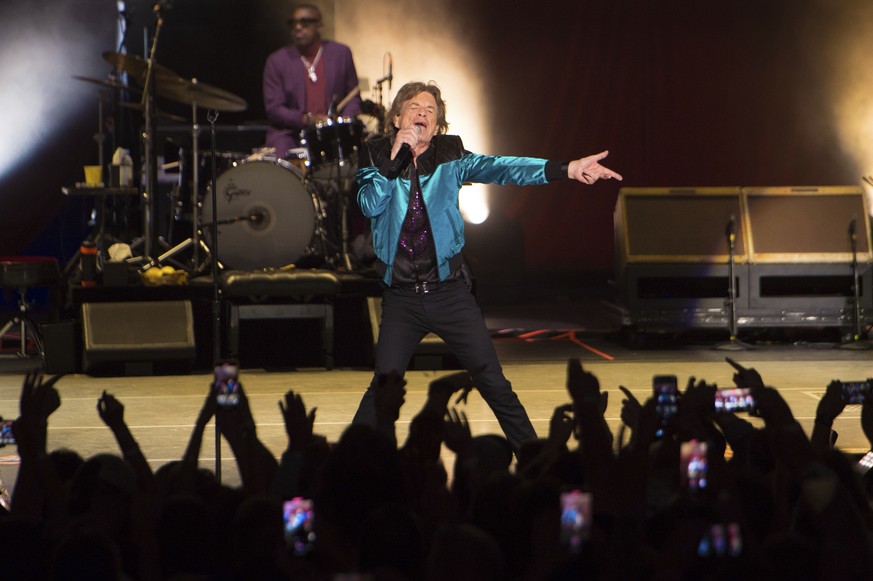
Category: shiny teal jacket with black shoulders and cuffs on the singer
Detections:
[{"x1": 356, "y1": 135, "x2": 561, "y2": 285}]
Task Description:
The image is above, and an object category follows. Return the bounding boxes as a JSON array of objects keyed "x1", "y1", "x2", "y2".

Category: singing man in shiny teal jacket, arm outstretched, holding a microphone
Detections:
[{"x1": 353, "y1": 82, "x2": 621, "y2": 451}]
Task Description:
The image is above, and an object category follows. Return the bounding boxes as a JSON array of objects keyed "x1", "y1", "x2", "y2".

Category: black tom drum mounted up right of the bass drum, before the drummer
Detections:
[{"x1": 300, "y1": 117, "x2": 364, "y2": 180}]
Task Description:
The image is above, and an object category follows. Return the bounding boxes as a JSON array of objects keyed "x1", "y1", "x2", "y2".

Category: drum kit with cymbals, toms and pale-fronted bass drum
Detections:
[{"x1": 74, "y1": 52, "x2": 374, "y2": 273}]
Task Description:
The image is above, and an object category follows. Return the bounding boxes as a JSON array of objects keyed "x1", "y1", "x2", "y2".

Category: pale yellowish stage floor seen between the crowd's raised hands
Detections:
[{"x1": 0, "y1": 292, "x2": 873, "y2": 496}]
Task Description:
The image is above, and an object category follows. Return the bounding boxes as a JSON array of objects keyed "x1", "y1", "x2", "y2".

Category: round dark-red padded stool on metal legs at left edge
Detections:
[{"x1": 0, "y1": 256, "x2": 60, "y2": 359}]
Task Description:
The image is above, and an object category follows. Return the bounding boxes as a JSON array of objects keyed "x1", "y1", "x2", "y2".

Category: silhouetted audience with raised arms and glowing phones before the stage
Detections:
[{"x1": 0, "y1": 360, "x2": 873, "y2": 580}]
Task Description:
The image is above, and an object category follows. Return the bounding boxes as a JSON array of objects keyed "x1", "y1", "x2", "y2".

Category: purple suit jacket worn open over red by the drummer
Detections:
[{"x1": 264, "y1": 40, "x2": 361, "y2": 157}]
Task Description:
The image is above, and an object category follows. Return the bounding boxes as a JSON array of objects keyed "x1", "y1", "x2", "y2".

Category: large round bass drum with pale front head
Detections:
[{"x1": 202, "y1": 158, "x2": 318, "y2": 270}]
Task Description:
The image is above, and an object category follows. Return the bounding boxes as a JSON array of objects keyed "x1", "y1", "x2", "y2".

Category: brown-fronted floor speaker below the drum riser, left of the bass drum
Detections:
[{"x1": 82, "y1": 301, "x2": 196, "y2": 375}]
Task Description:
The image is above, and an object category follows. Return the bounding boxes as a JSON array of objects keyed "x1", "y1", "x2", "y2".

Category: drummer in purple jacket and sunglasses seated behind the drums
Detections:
[{"x1": 264, "y1": 4, "x2": 361, "y2": 158}]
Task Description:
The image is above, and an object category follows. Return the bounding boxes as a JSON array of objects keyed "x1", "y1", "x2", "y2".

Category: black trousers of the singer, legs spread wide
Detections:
[{"x1": 352, "y1": 278, "x2": 537, "y2": 450}]
